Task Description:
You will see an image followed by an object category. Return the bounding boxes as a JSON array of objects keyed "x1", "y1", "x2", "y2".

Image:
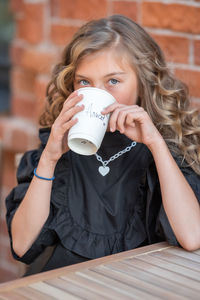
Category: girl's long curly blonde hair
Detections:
[{"x1": 40, "y1": 15, "x2": 200, "y2": 175}]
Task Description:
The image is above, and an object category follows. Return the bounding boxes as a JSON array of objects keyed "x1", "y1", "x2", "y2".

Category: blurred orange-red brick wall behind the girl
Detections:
[{"x1": 0, "y1": 0, "x2": 200, "y2": 281}]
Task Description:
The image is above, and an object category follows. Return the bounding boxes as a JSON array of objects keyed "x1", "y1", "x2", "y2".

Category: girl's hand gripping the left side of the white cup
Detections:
[{"x1": 43, "y1": 91, "x2": 84, "y2": 162}]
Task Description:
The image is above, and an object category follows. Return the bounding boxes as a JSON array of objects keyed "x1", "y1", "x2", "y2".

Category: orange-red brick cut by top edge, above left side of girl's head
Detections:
[{"x1": 58, "y1": 0, "x2": 107, "y2": 20}]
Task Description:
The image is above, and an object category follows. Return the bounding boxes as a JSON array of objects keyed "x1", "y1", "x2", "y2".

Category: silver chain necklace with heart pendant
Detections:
[{"x1": 95, "y1": 142, "x2": 137, "y2": 176}]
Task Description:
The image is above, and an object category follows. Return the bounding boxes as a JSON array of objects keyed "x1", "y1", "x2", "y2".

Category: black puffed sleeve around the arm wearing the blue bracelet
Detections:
[{"x1": 6, "y1": 150, "x2": 55, "y2": 264}]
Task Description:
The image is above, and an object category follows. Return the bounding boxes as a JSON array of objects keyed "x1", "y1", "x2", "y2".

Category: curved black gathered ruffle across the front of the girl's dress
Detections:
[{"x1": 43, "y1": 146, "x2": 146, "y2": 259}]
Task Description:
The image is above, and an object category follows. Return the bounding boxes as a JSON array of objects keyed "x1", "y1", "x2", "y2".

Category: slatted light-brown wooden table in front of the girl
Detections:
[{"x1": 0, "y1": 243, "x2": 200, "y2": 300}]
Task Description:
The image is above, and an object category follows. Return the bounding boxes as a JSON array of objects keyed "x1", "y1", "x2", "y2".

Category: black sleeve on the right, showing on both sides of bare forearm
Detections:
[{"x1": 156, "y1": 160, "x2": 200, "y2": 246}]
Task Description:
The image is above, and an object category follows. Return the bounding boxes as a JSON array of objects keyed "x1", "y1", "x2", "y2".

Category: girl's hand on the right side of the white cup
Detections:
[{"x1": 102, "y1": 103, "x2": 163, "y2": 149}]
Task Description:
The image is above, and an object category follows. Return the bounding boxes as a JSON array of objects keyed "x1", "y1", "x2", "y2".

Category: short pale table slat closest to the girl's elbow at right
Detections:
[{"x1": 149, "y1": 251, "x2": 200, "y2": 277}]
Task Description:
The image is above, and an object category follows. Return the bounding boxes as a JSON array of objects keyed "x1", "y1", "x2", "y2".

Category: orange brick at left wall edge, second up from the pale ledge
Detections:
[{"x1": 11, "y1": 68, "x2": 35, "y2": 94}]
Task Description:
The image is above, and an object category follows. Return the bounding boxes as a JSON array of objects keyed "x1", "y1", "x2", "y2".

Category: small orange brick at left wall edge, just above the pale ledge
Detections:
[{"x1": 11, "y1": 95, "x2": 35, "y2": 120}]
